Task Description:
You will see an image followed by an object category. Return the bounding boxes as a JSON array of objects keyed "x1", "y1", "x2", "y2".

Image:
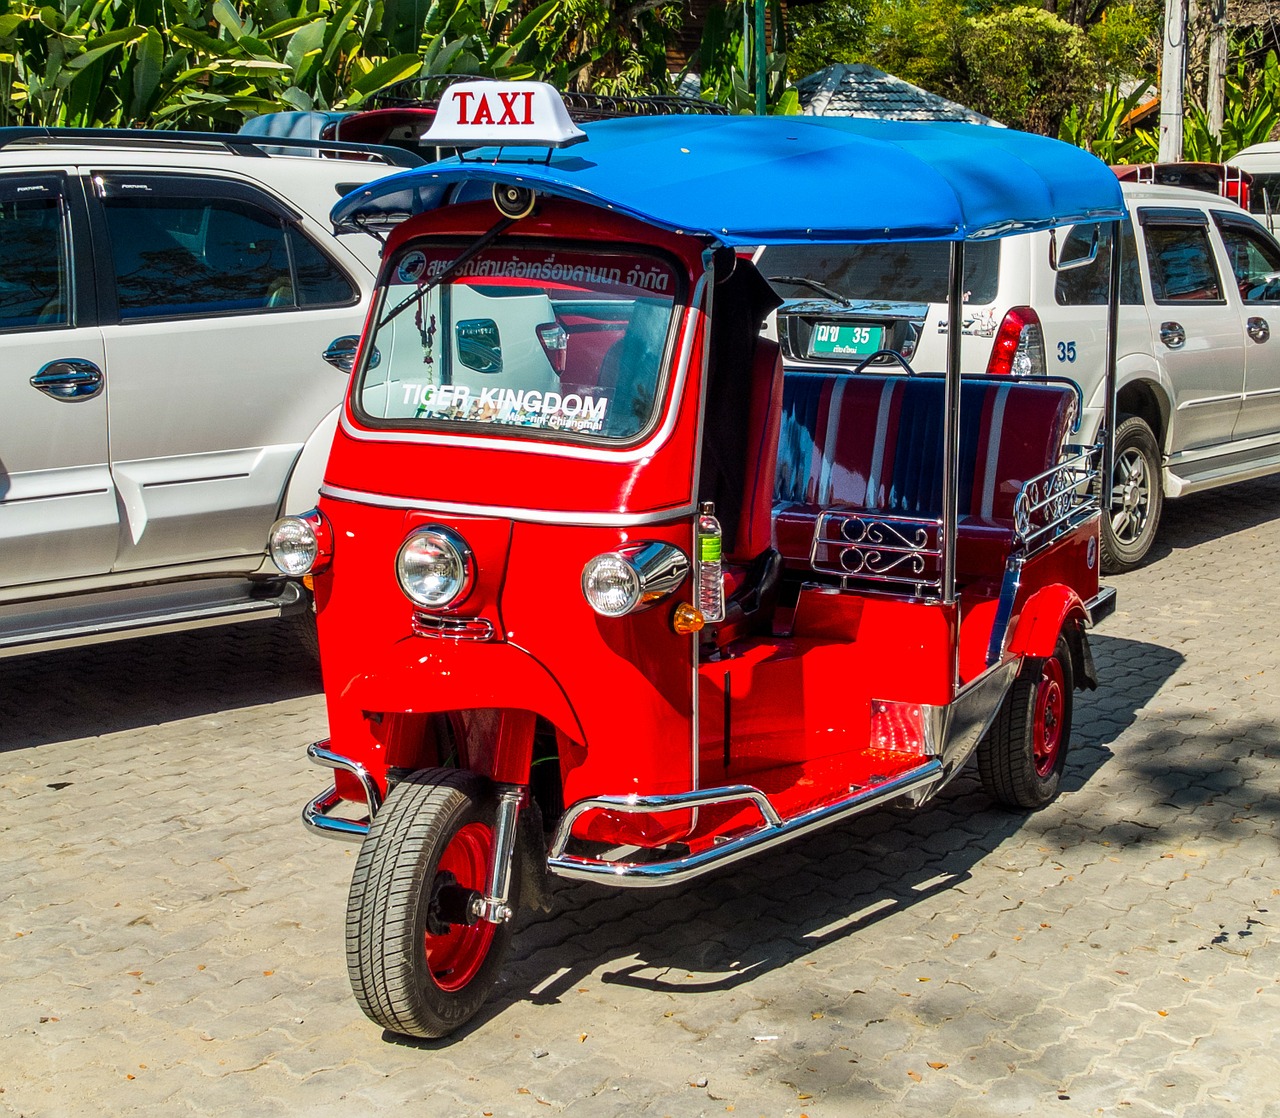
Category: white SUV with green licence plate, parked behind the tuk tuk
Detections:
[{"x1": 758, "y1": 183, "x2": 1280, "y2": 572}]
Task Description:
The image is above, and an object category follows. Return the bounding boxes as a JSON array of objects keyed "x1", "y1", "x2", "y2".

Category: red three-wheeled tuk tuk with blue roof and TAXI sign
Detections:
[{"x1": 271, "y1": 83, "x2": 1121, "y2": 1036}]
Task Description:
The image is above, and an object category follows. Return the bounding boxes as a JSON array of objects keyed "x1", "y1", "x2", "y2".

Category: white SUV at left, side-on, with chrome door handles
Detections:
[{"x1": 0, "y1": 128, "x2": 420, "y2": 656}]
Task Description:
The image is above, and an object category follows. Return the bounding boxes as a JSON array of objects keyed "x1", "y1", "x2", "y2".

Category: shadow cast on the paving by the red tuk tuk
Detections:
[{"x1": 409, "y1": 634, "x2": 1198, "y2": 1048}]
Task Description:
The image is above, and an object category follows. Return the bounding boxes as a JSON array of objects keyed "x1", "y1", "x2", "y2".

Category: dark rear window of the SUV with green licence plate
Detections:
[{"x1": 758, "y1": 241, "x2": 1000, "y2": 304}]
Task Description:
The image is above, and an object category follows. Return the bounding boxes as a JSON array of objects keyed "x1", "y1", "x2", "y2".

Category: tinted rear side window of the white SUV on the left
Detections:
[{"x1": 102, "y1": 192, "x2": 357, "y2": 320}]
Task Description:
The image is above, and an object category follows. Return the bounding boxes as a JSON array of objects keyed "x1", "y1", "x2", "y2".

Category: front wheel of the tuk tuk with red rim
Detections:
[{"x1": 347, "y1": 768, "x2": 520, "y2": 1037}]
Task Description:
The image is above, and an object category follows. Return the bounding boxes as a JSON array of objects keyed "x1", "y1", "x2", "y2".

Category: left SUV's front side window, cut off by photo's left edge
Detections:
[{"x1": 0, "y1": 178, "x2": 70, "y2": 330}]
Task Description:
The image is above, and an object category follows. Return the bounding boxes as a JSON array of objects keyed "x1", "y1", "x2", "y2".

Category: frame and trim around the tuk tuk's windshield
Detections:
[{"x1": 348, "y1": 234, "x2": 690, "y2": 451}]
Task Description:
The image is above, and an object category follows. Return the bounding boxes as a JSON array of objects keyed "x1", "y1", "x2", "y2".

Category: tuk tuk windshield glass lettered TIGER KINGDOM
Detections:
[{"x1": 353, "y1": 242, "x2": 681, "y2": 441}]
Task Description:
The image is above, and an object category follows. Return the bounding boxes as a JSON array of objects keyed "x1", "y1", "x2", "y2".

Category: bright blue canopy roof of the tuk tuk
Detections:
[{"x1": 332, "y1": 117, "x2": 1123, "y2": 245}]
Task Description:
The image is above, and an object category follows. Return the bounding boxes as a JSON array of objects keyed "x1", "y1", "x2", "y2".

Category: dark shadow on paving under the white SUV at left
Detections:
[{"x1": 0, "y1": 620, "x2": 320, "y2": 753}]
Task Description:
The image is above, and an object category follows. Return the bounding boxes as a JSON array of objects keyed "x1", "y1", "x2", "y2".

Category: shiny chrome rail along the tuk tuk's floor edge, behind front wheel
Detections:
[{"x1": 547, "y1": 758, "x2": 943, "y2": 887}]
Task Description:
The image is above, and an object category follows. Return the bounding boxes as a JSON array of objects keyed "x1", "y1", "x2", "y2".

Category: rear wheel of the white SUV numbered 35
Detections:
[{"x1": 1102, "y1": 415, "x2": 1165, "y2": 575}]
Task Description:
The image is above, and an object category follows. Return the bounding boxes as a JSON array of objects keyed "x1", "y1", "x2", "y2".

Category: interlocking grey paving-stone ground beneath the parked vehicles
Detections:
[{"x1": 0, "y1": 479, "x2": 1280, "y2": 1118}]
